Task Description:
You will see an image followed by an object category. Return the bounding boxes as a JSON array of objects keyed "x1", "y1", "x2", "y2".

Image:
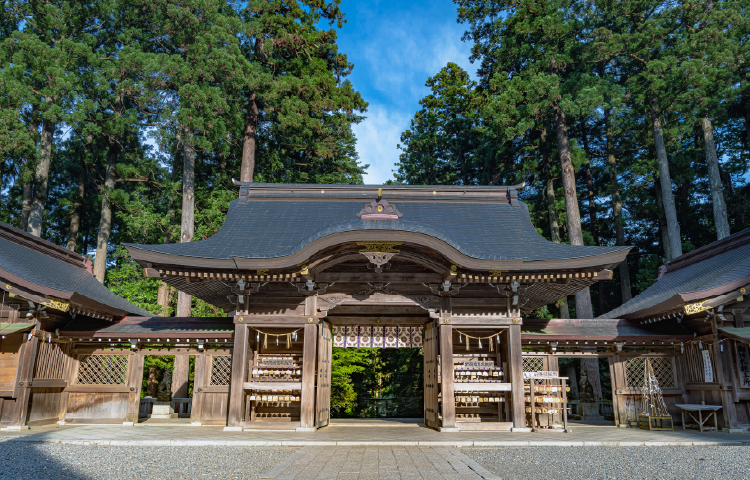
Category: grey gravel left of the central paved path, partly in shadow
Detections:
[{"x1": 0, "y1": 440, "x2": 298, "y2": 480}]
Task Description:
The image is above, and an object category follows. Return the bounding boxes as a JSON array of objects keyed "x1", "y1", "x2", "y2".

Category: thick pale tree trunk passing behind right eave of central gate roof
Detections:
[{"x1": 555, "y1": 109, "x2": 594, "y2": 318}]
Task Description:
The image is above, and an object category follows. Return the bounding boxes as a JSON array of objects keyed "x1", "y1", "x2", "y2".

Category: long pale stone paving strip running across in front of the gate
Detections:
[{"x1": 5, "y1": 424, "x2": 750, "y2": 447}]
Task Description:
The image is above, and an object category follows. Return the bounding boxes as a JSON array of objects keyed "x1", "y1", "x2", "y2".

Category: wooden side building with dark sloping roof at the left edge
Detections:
[{"x1": 0, "y1": 222, "x2": 151, "y2": 428}]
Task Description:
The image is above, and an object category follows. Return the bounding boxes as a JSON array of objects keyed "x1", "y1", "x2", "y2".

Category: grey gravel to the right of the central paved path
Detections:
[{"x1": 468, "y1": 446, "x2": 750, "y2": 480}]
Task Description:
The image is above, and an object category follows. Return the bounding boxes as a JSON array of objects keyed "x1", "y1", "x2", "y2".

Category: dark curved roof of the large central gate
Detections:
[{"x1": 127, "y1": 185, "x2": 629, "y2": 261}]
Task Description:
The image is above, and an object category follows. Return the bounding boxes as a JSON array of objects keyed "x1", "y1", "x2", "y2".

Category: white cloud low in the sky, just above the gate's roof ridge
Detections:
[{"x1": 353, "y1": 104, "x2": 411, "y2": 185}]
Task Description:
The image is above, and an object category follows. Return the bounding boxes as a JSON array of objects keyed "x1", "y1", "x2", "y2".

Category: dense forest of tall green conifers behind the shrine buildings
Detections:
[{"x1": 0, "y1": 0, "x2": 750, "y2": 415}]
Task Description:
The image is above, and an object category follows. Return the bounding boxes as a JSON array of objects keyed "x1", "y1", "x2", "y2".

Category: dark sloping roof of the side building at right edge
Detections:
[{"x1": 599, "y1": 229, "x2": 750, "y2": 318}]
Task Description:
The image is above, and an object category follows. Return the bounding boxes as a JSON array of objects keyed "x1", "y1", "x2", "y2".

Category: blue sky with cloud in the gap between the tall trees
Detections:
[{"x1": 338, "y1": 0, "x2": 476, "y2": 184}]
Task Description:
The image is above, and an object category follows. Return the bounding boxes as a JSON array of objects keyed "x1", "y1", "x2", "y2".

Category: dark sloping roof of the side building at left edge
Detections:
[{"x1": 0, "y1": 222, "x2": 151, "y2": 317}]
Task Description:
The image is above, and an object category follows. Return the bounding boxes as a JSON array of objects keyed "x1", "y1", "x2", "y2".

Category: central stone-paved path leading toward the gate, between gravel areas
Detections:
[{"x1": 261, "y1": 446, "x2": 498, "y2": 480}]
